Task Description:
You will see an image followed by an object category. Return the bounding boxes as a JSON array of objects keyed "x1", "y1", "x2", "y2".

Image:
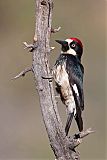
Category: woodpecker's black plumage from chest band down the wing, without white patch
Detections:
[{"x1": 55, "y1": 54, "x2": 84, "y2": 110}]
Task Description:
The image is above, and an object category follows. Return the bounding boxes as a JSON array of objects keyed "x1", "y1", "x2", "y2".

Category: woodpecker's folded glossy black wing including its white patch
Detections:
[{"x1": 66, "y1": 55, "x2": 84, "y2": 110}]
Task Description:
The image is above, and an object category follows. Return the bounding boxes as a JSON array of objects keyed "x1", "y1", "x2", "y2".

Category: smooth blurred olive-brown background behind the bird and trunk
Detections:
[{"x1": 0, "y1": 0, "x2": 107, "y2": 160}]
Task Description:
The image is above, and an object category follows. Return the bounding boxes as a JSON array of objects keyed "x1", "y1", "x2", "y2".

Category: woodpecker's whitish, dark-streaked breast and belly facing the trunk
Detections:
[{"x1": 53, "y1": 64, "x2": 76, "y2": 115}]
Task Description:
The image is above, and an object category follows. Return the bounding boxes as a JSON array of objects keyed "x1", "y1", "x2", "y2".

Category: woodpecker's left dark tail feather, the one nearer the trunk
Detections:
[{"x1": 65, "y1": 112, "x2": 74, "y2": 136}]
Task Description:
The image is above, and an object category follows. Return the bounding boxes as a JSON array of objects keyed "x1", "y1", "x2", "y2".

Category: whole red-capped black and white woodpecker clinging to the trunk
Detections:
[{"x1": 53, "y1": 38, "x2": 84, "y2": 135}]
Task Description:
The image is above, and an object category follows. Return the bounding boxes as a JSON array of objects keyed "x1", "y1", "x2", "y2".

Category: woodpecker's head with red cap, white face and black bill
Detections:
[{"x1": 56, "y1": 38, "x2": 83, "y2": 59}]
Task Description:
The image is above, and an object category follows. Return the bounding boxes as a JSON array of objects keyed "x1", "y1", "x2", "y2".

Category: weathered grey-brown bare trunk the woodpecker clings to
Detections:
[{"x1": 33, "y1": 0, "x2": 72, "y2": 160}]
